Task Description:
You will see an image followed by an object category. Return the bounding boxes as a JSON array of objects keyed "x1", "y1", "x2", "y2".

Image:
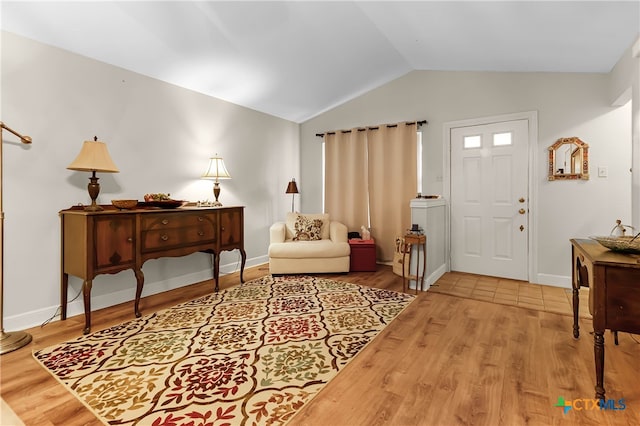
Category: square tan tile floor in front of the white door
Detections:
[{"x1": 429, "y1": 272, "x2": 591, "y2": 318}]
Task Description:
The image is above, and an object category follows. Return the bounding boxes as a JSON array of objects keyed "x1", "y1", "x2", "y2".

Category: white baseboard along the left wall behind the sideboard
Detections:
[{"x1": 4, "y1": 256, "x2": 269, "y2": 332}]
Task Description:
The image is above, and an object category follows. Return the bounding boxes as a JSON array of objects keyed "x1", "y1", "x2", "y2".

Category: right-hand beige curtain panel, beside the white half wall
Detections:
[{"x1": 367, "y1": 123, "x2": 417, "y2": 262}]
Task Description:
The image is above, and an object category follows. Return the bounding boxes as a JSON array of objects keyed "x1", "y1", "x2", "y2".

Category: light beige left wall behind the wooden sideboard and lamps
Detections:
[{"x1": 1, "y1": 32, "x2": 299, "y2": 330}]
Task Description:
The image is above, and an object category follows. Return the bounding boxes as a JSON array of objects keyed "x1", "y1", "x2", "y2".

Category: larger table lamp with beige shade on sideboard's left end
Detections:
[{"x1": 67, "y1": 136, "x2": 120, "y2": 212}]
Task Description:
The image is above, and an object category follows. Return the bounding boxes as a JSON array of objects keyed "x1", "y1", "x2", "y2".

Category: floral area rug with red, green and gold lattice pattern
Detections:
[{"x1": 33, "y1": 276, "x2": 414, "y2": 426}]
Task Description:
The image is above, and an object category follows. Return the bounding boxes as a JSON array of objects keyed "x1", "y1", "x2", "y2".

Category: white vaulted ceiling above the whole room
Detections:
[{"x1": 0, "y1": 0, "x2": 640, "y2": 122}]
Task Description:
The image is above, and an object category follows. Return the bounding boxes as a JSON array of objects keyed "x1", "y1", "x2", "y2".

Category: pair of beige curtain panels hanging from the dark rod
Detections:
[{"x1": 325, "y1": 123, "x2": 417, "y2": 262}]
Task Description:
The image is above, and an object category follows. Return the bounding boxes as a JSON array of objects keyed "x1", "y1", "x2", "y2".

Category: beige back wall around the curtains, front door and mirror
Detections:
[{"x1": 300, "y1": 71, "x2": 631, "y2": 285}]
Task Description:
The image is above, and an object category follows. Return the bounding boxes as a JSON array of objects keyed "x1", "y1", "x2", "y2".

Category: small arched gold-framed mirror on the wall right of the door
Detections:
[{"x1": 548, "y1": 137, "x2": 589, "y2": 180}]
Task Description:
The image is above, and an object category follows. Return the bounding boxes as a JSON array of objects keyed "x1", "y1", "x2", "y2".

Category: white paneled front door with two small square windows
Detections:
[{"x1": 450, "y1": 120, "x2": 529, "y2": 280}]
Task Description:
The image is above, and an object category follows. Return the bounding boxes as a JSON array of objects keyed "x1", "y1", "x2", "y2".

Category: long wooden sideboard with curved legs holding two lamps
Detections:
[{"x1": 60, "y1": 206, "x2": 247, "y2": 334}]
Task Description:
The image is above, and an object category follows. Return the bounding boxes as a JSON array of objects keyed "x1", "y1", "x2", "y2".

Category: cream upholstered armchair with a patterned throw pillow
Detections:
[{"x1": 269, "y1": 213, "x2": 351, "y2": 274}]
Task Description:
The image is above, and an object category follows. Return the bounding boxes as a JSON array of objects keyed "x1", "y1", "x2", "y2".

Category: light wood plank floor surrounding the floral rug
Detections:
[{"x1": 0, "y1": 266, "x2": 640, "y2": 426}]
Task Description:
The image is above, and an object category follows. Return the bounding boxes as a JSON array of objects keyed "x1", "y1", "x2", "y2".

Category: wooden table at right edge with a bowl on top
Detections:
[{"x1": 571, "y1": 239, "x2": 640, "y2": 399}]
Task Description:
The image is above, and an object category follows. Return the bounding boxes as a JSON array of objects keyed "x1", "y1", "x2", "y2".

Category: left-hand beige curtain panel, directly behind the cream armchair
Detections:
[{"x1": 324, "y1": 129, "x2": 369, "y2": 231}]
